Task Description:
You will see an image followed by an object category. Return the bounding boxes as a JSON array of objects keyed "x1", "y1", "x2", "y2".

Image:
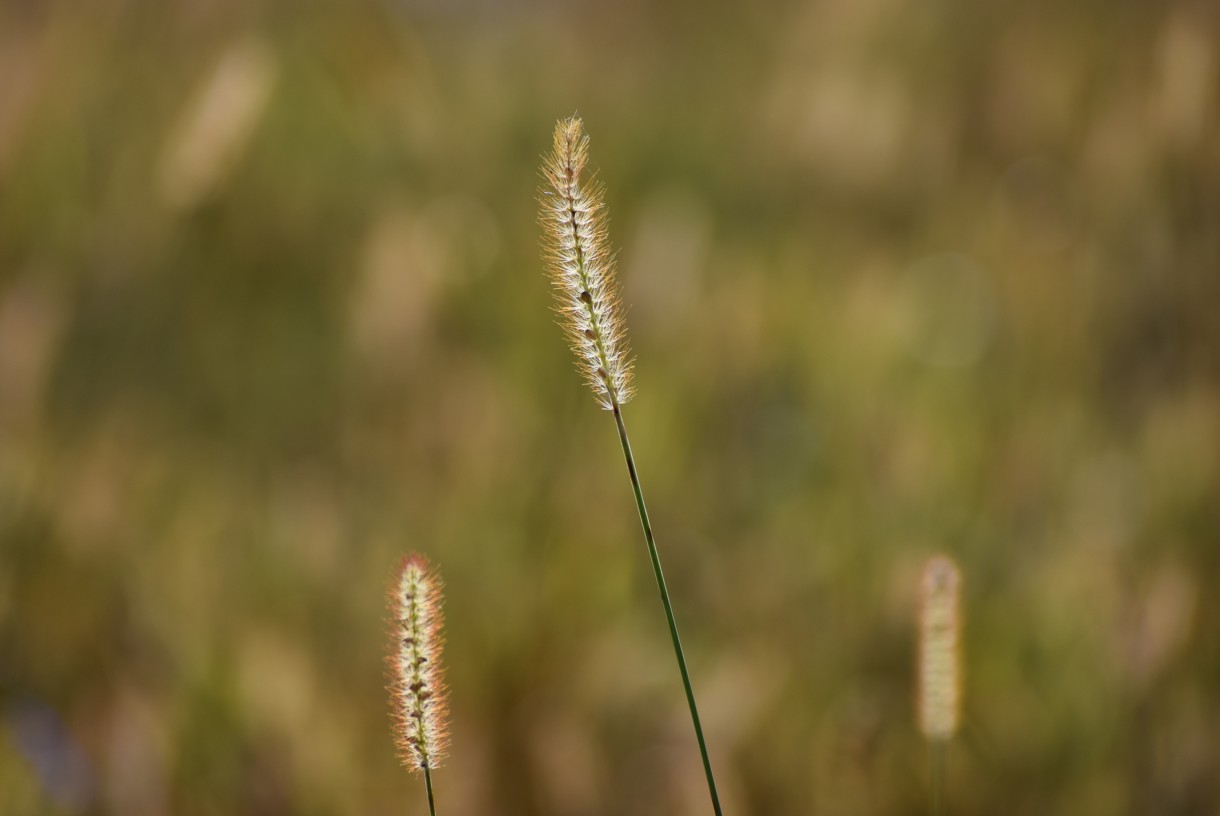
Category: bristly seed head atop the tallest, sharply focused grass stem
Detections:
[{"x1": 538, "y1": 116, "x2": 632, "y2": 411}]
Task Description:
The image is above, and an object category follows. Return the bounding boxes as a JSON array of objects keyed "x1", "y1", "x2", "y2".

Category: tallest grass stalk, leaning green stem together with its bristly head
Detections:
[{"x1": 539, "y1": 116, "x2": 722, "y2": 816}]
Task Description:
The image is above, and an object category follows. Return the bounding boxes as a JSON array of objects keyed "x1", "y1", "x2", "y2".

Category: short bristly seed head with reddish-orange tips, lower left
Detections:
[{"x1": 387, "y1": 553, "x2": 448, "y2": 771}]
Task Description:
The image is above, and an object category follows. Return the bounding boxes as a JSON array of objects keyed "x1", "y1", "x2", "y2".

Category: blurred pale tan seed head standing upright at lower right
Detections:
[{"x1": 919, "y1": 555, "x2": 961, "y2": 740}]
